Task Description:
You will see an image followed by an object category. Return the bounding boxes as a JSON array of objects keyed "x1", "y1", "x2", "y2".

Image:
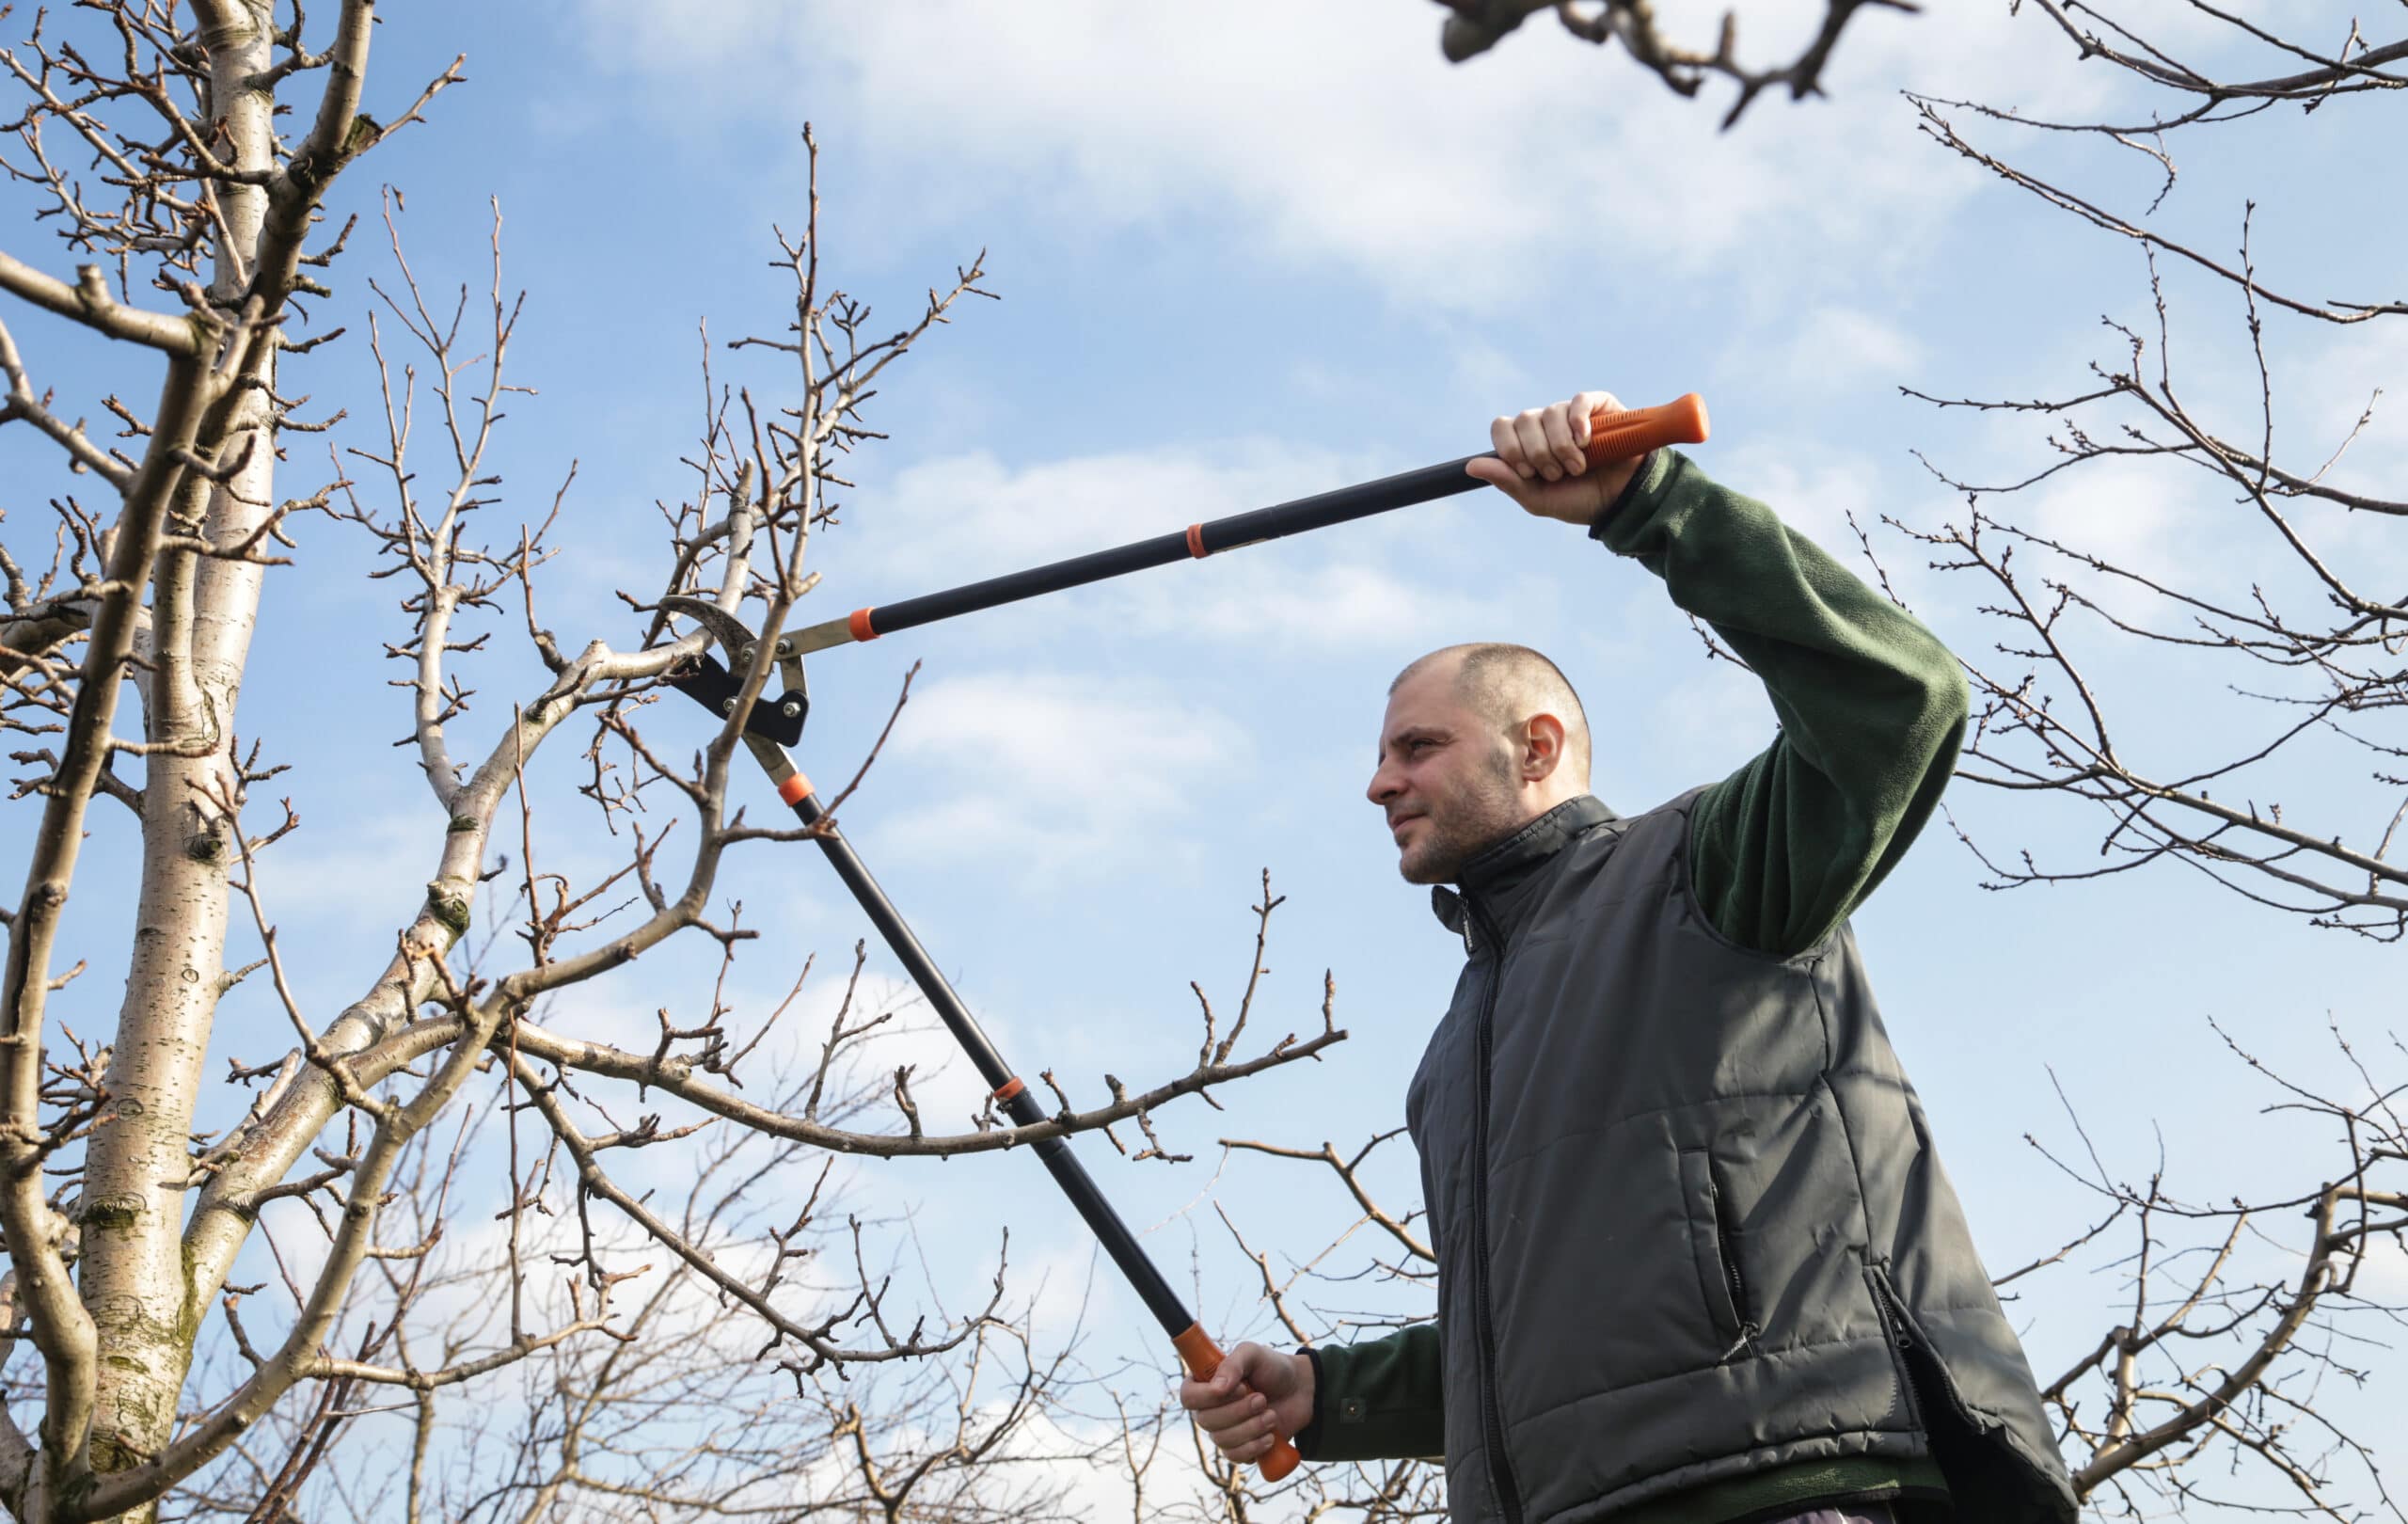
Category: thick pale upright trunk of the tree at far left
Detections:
[{"x1": 77, "y1": 0, "x2": 275, "y2": 1519}]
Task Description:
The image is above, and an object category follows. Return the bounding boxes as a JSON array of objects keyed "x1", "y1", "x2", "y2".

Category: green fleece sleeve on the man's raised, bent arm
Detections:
[{"x1": 1592, "y1": 451, "x2": 1965, "y2": 956}]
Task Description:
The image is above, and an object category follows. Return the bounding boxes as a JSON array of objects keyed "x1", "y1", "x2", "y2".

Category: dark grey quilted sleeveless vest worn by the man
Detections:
[{"x1": 1406, "y1": 792, "x2": 2076, "y2": 1524}]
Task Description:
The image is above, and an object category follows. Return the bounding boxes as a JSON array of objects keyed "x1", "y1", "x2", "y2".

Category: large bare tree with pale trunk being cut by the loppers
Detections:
[{"x1": 0, "y1": 0, "x2": 1343, "y2": 1524}]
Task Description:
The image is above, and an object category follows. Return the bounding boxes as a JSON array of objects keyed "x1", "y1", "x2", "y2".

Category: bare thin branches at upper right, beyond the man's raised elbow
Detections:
[{"x1": 1908, "y1": 5, "x2": 2408, "y2": 942}]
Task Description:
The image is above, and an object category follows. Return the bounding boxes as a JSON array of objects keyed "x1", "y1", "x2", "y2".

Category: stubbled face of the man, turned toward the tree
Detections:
[{"x1": 1363, "y1": 662, "x2": 1522, "y2": 883}]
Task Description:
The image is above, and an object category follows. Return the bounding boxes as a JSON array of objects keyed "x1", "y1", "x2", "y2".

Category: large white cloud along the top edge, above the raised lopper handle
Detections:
[{"x1": 568, "y1": 0, "x2": 2167, "y2": 310}]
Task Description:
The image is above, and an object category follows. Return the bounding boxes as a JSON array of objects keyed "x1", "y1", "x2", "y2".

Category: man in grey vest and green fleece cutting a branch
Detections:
[{"x1": 1180, "y1": 392, "x2": 2076, "y2": 1524}]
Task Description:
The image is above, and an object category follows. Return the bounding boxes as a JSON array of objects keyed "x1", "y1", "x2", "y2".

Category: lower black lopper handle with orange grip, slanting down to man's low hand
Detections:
[{"x1": 778, "y1": 758, "x2": 1298, "y2": 1481}]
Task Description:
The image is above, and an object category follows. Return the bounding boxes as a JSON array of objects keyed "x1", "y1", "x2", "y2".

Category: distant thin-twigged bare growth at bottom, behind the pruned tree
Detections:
[{"x1": 150, "y1": 1059, "x2": 1076, "y2": 1521}]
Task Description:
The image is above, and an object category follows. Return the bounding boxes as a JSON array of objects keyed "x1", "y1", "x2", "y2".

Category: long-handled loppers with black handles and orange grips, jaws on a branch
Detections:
[{"x1": 662, "y1": 392, "x2": 1704, "y2": 1481}]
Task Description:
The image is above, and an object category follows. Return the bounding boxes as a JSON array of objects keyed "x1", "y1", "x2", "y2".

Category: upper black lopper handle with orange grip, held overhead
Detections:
[{"x1": 792, "y1": 392, "x2": 1704, "y2": 653}]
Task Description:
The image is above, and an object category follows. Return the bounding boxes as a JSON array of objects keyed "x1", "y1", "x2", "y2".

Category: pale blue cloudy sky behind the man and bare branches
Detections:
[{"x1": 0, "y1": 0, "x2": 2408, "y2": 1512}]
